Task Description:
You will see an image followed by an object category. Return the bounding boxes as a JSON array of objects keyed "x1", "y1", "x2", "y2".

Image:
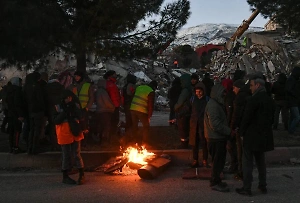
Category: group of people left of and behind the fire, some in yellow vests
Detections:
[{"x1": 1, "y1": 70, "x2": 158, "y2": 184}]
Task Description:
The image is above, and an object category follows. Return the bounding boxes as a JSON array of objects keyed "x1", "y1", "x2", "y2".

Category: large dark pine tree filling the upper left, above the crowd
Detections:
[{"x1": 0, "y1": 0, "x2": 190, "y2": 71}]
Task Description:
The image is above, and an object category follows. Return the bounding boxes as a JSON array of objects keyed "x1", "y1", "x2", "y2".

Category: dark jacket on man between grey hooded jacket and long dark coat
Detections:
[{"x1": 230, "y1": 85, "x2": 251, "y2": 130}]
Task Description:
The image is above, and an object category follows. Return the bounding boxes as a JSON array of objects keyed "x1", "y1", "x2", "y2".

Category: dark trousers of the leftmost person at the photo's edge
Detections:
[{"x1": 8, "y1": 117, "x2": 22, "y2": 150}]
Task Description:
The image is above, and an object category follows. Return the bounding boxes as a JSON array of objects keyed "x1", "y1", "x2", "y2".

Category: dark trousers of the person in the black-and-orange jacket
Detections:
[{"x1": 61, "y1": 141, "x2": 84, "y2": 171}]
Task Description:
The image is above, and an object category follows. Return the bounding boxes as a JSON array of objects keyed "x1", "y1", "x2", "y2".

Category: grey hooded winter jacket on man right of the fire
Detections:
[{"x1": 204, "y1": 84, "x2": 231, "y2": 141}]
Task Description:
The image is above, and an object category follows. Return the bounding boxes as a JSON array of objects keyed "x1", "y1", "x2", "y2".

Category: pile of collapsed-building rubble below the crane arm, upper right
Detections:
[{"x1": 206, "y1": 31, "x2": 300, "y2": 82}]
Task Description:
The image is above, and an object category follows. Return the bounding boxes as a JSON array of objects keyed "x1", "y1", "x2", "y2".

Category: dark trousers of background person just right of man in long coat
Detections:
[{"x1": 273, "y1": 100, "x2": 289, "y2": 130}]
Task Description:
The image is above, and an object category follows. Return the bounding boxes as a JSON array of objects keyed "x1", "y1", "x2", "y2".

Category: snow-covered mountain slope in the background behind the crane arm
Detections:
[{"x1": 171, "y1": 23, "x2": 263, "y2": 47}]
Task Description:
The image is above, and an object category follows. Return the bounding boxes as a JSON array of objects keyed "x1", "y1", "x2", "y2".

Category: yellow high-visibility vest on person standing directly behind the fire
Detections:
[{"x1": 130, "y1": 85, "x2": 153, "y2": 114}]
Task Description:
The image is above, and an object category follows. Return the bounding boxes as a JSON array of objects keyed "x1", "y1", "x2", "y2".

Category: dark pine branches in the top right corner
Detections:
[{"x1": 247, "y1": 0, "x2": 300, "y2": 36}]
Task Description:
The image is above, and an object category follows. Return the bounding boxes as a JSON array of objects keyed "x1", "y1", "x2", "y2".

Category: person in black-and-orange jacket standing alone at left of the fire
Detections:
[{"x1": 54, "y1": 90, "x2": 85, "y2": 185}]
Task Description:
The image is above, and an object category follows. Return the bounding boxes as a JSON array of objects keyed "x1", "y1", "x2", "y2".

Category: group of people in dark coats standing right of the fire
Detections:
[{"x1": 168, "y1": 67, "x2": 300, "y2": 196}]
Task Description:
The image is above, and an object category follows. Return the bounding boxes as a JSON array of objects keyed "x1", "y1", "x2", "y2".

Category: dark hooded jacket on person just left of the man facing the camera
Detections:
[{"x1": 174, "y1": 74, "x2": 192, "y2": 116}]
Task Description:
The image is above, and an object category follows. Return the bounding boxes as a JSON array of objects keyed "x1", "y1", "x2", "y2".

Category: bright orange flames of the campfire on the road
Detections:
[{"x1": 123, "y1": 146, "x2": 155, "y2": 165}]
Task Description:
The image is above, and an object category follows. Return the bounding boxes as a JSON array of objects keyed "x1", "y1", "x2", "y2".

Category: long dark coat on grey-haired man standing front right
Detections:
[{"x1": 239, "y1": 88, "x2": 275, "y2": 152}]
